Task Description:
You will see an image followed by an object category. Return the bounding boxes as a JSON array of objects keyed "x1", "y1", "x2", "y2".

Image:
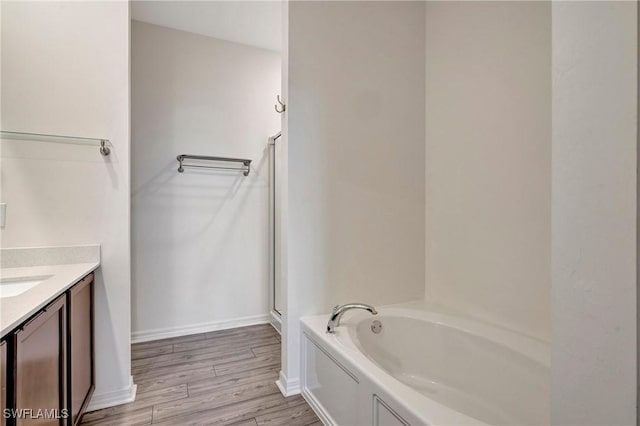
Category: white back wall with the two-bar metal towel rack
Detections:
[{"x1": 132, "y1": 21, "x2": 281, "y2": 340}]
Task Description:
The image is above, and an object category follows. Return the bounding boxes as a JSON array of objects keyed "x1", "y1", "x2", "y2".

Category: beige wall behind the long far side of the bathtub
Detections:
[{"x1": 425, "y1": 2, "x2": 551, "y2": 341}]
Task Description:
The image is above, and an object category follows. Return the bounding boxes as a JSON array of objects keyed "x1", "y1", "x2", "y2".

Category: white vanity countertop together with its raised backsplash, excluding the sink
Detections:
[{"x1": 0, "y1": 246, "x2": 100, "y2": 337}]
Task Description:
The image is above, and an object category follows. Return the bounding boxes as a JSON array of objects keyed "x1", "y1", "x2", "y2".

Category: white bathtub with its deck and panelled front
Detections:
[{"x1": 301, "y1": 305, "x2": 550, "y2": 426}]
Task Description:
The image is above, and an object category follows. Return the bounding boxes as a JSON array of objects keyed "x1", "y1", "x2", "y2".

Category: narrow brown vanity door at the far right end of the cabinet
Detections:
[{"x1": 68, "y1": 274, "x2": 94, "y2": 425}]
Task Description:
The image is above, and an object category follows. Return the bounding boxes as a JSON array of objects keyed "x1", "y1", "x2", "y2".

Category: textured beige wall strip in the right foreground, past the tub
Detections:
[{"x1": 551, "y1": 2, "x2": 638, "y2": 425}]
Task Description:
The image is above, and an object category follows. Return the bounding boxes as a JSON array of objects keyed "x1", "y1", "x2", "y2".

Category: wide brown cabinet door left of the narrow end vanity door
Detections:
[{"x1": 15, "y1": 295, "x2": 67, "y2": 425}]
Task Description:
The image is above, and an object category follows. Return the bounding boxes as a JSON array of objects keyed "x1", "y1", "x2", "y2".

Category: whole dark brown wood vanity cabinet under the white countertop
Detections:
[{"x1": 0, "y1": 273, "x2": 95, "y2": 426}]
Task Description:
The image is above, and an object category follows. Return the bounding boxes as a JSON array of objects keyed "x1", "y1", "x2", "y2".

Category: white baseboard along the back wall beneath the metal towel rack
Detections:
[{"x1": 131, "y1": 314, "x2": 270, "y2": 343}]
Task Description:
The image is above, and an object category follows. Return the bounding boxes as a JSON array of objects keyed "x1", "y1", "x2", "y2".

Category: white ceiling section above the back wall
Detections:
[{"x1": 131, "y1": 0, "x2": 282, "y2": 51}]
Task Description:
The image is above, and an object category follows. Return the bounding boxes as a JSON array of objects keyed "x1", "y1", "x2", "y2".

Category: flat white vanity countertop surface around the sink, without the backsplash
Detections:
[{"x1": 0, "y1": 261, "x2": 100, "y2": 337}]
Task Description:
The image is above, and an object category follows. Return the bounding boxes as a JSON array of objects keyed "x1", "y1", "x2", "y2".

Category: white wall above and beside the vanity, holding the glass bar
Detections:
[{"x1": 0, "y1": 2, "x2": 131, "y2": 410}]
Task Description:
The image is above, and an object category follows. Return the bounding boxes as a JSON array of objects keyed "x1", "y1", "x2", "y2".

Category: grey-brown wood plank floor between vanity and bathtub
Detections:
[{"x1": 82, "y1": 325, "x2": 322, "y2": 426}]
